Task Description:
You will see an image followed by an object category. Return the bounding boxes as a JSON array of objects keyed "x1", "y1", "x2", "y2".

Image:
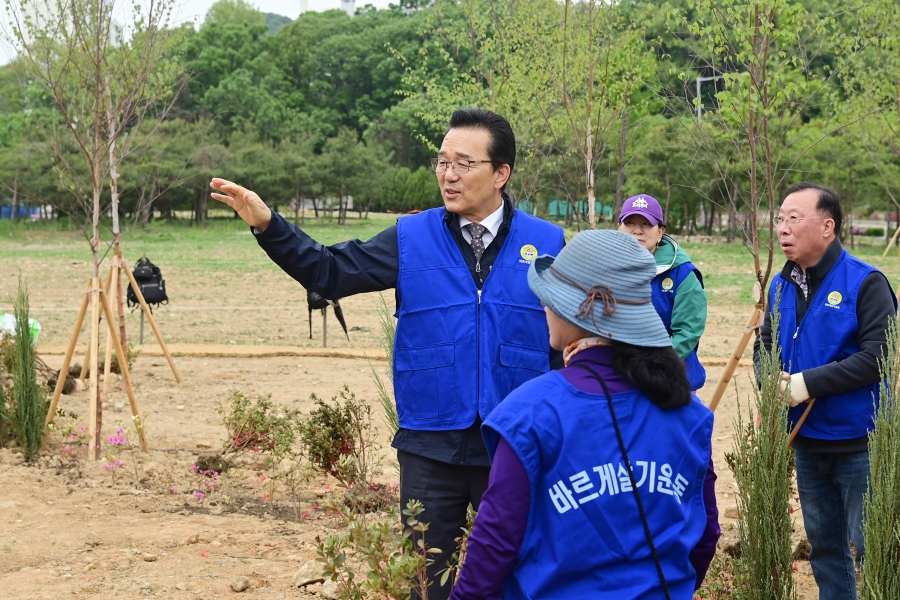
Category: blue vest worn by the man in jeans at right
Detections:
[{"x1": 769, "y1": 250, "x2": 897, "y2": 440}]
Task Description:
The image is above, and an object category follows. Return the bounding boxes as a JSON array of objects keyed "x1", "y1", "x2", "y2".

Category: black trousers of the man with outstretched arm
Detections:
[{"x1": 397, "y1": 450, "x2": 491, "y2": 600}]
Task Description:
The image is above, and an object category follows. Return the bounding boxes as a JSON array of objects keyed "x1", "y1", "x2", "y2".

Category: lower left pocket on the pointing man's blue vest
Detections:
[{"x1": 394, "y1": 343, "x2": 459, "y2": 425}]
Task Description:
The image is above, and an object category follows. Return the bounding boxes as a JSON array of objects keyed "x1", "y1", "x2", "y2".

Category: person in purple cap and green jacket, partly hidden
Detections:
[{"x1": 619, "y1": 194, "x2": 706, "y2": 391}]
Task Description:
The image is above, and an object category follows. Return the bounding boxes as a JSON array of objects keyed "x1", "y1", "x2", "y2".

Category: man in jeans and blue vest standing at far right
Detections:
[{"x1": 753, "y1": 183, "x2": 897, "y2": 600}]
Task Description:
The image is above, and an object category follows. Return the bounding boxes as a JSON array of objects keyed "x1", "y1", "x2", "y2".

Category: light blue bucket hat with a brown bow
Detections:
[{"x1": 528, "y1": 229, "x2": 672, "y2": 348}]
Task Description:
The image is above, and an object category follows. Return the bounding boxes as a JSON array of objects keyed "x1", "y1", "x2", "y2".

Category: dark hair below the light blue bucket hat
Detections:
[{"x1": 612, "y1": 342, "x2": 691, "y2": 410}]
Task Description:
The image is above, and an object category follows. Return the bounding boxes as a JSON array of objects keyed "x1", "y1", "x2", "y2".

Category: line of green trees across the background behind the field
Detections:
[{"x1": 0, "y1": 0, "x2": 900, "y2": 241}]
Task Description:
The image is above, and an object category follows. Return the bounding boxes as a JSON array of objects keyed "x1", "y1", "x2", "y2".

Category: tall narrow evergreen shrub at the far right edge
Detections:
[{"x1": 859, "y1": 318, "x2": 900, "y2": 600}]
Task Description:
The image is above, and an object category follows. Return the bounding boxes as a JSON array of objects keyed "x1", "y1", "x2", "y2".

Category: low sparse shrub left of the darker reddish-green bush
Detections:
[{"x1": 216, "y1": 391, "x2": 296, "y2": 457}]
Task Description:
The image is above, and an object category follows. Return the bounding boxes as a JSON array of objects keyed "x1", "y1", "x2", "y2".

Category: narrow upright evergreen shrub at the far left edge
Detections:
[{"x1": 13, "y1": 276, "x2": 47, "y2": 460}]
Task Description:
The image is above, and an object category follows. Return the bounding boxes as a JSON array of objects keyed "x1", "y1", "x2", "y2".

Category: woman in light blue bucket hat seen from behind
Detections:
[{"x1": 451, "y1": 230, "x2": 720, "y2": 600}]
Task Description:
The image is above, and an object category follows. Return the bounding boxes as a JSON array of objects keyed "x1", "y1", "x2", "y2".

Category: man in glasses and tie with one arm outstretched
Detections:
[{"x1": 211, "y1": 109, "x2": 563, "y2": 600}]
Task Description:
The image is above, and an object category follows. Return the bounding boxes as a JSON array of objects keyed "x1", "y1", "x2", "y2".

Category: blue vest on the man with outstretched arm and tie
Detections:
[{"x1": 394, "y1": 208, "x2": 563, "y2": 431}]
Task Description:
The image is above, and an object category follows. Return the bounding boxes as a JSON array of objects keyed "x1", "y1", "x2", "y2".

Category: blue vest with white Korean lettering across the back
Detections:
[{"x1": 482, "y1": 372, "x2": 713, "y2": 600}]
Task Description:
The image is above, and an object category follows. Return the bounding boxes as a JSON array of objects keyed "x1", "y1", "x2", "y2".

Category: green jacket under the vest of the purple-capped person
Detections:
[{"x1": 653, "y1": 235, "x2": 706, "y2": 360}]
